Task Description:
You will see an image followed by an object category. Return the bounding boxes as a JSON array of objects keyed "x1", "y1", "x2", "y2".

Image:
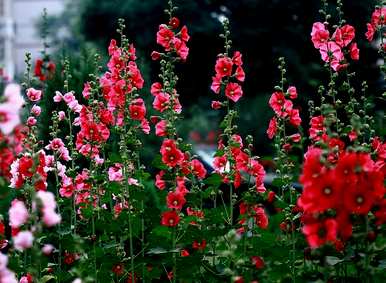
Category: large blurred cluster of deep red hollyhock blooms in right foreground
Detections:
[{"x1": 298, "y1": 150, "x2": 385, "y2": 248}]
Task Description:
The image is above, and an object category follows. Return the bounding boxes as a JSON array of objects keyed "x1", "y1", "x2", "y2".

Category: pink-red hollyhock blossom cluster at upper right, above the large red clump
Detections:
[{"x1": 311, "y1": 22, "x2": 359, "y2": 72}]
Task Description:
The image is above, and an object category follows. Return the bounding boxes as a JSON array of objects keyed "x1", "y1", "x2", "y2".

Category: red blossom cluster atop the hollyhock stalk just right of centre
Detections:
[{"x1": 211, "y1": 51, "x2": 245, "y2": 104}]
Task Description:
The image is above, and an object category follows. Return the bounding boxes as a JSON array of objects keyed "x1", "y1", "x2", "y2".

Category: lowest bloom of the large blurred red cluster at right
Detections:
[{"x1": 302, "y1": 218, "x2": 338, "y2": 249}]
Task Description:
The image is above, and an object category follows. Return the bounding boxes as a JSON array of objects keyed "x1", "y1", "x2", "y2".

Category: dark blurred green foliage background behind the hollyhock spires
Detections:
[{"x1": 42, "y1": 0, "x2": 383, "y2": 158}]
